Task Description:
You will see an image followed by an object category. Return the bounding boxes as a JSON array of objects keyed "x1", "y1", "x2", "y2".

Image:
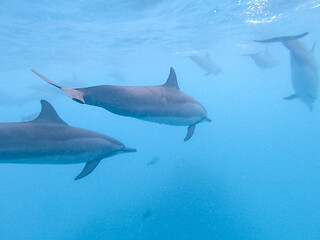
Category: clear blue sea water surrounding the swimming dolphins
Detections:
[{"x1": 0, "y1": 0, "x2": 320, "y2": 240}]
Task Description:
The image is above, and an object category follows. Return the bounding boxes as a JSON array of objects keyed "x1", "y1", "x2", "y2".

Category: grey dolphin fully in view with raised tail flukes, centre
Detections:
[{"x1": 32, "y1": 68, "x2": 211, "y2": 141}]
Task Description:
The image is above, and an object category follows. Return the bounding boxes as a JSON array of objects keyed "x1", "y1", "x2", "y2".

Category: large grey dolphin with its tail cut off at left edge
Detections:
[{"x1": 0, "y1": 100, "x2": 136, "y2": 180}]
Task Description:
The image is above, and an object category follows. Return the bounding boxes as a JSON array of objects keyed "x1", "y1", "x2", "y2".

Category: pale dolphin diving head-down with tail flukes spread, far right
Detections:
[{"x1": 255, "y1": 32, "x2": 319, "y2": 111}]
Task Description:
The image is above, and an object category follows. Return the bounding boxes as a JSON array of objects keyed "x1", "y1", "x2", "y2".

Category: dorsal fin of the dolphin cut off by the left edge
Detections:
[{"x1": 33, "y1": 100, "x2": 67, "y2": 125}]
